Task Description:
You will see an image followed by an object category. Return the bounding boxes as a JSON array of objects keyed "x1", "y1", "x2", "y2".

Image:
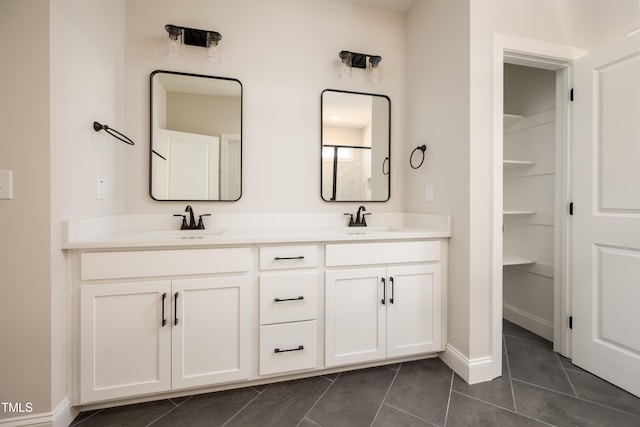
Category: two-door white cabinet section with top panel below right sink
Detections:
[{"x1": 325, "y1": 240, "x2": 444, "y2": 367}]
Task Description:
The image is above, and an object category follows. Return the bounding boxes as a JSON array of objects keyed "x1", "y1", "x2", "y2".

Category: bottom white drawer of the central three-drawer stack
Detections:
[{"x1": 260, "y1": 320, "x2": 318, "y2": 375}]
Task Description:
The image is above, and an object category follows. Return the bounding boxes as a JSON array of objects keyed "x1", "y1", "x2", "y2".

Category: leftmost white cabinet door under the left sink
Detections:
[{"x1": 80, "y1": 281, "x2": 171, "y2": 403}]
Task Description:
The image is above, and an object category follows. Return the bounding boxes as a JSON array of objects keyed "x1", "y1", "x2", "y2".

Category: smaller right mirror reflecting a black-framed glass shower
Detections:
[{"x1": 321, "y1": 89, "x2": 391, "y2": 202}]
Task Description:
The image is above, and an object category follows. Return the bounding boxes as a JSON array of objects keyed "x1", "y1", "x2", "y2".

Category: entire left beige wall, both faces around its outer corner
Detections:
[{"x1": 0, "y1": 0, "x2": 124, "y2": 423}]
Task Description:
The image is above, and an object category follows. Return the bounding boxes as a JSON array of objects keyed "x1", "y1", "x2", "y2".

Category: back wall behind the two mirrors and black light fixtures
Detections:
[{"x1": 125, "y1": 0, "x2": 405, "y2": 215}]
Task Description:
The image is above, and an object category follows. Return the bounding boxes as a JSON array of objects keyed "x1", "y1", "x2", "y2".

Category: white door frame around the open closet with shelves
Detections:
[{"x1": 491, "y1": 33, "x2": 587, "y2": 378}]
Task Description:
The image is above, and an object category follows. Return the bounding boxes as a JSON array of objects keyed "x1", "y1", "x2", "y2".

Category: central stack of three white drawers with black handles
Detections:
[{"x1": 259, "y1": 245, "x2": 319, "y2": 375}]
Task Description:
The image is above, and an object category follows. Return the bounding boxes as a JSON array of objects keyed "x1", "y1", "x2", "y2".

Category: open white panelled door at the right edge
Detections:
[{"x1": 572, "y1": 35, "x2": 640, "y2": 396}]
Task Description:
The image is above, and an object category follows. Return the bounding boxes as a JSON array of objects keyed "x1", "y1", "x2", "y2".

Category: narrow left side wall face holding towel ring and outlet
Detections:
[{"x1": 50, "y1": 0, "x2": 129, "y2": 422}]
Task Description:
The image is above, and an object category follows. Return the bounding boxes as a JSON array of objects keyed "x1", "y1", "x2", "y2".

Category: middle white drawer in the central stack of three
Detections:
[{"x1": 260, "y1": 271, "x2": 318, "y2": 325}]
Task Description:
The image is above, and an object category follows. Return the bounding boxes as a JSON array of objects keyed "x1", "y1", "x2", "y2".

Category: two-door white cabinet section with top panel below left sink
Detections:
[{"x1": 79, "y1": 248, "x2": 251, "y2": 403}]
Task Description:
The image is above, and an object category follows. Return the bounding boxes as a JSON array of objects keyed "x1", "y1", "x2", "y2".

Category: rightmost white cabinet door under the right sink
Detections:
[{"x1": 387, "y1": 264, "x2": 442, "y2": 357}]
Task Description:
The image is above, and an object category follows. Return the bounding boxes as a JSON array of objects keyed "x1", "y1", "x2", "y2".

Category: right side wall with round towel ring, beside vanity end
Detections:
[{"x1": 402, "y1": 0, "x2": 470, "y2": 354}]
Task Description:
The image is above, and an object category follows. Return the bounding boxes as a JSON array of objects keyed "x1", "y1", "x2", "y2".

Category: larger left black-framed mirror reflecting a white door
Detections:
[{"x1": 149, "y1": 71, "x2": 242, "y2": 201}]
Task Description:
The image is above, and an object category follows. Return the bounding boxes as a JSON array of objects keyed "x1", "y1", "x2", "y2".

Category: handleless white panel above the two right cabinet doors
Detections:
[{"x1": 325, "y1": 240, "x2": 441, "y2": 267}]
